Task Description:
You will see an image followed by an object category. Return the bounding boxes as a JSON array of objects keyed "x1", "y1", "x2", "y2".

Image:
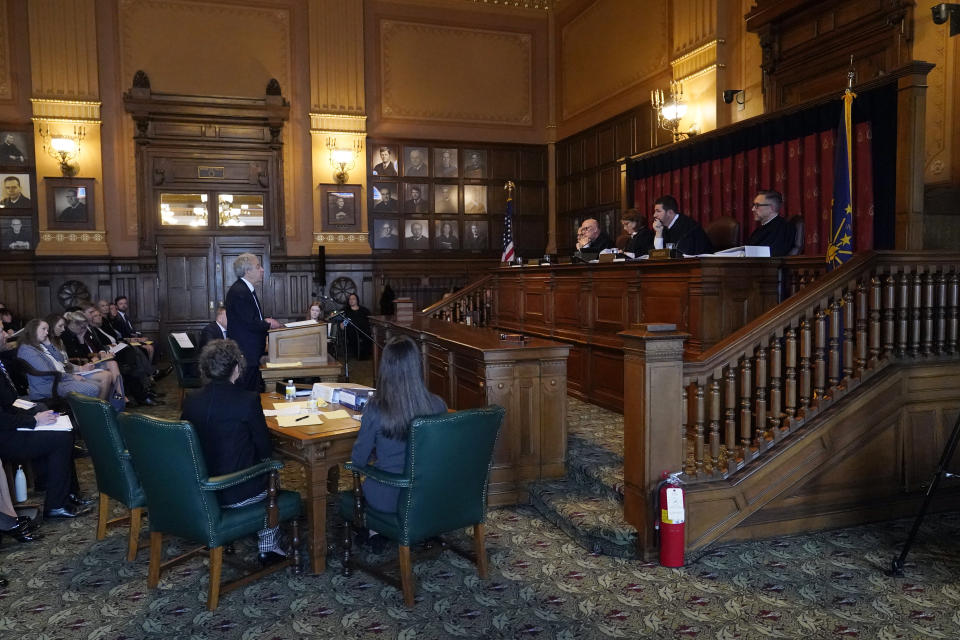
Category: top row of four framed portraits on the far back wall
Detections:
[{"x1": 367, "y1": 144, "x2": 487, "y2": 178}]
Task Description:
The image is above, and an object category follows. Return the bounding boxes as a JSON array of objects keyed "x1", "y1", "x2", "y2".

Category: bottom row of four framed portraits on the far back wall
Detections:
[{"x1": 370, "y1": 216, "x2": 490, "y2": 251}]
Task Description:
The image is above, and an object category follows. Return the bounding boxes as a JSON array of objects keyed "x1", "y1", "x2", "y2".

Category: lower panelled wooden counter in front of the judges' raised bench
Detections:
[{"x1": 370, "y1": 316, "x2": 570, "y2": 505}]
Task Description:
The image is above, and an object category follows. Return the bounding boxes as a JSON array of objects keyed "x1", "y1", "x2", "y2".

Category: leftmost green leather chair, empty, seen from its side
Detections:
[{"x1": 67, "y1": 393, "x2": 147, "y2": 562}]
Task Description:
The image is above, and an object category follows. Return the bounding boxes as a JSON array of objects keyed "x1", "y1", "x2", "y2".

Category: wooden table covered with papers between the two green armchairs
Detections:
[{"x1": 260, "y1": 393, "x2": 360, "y2": 573}]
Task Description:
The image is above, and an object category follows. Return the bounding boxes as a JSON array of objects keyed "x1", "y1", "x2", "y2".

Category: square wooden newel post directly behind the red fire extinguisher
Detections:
[{"x1": 618, "y1": 324, "x2": 690, "y2": 560}]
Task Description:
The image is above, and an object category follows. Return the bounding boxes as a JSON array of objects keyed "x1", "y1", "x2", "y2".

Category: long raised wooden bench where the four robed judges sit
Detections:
[{"x1": 488, "y1": 258, "x2": 808, "y2": 411}]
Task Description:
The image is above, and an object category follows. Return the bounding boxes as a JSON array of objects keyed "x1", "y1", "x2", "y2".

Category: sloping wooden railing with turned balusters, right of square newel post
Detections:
[{"x1": 677, "y1": 253, "x2": 960, "y2": 482}]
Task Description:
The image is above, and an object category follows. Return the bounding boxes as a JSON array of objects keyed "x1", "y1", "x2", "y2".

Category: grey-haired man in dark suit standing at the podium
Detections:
[{"x1": 224, "y1": 253, "x2": 280, "y2": 393}]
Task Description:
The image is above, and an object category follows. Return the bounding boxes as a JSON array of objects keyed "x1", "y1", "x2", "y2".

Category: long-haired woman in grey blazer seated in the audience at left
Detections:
[{"x1": 17, "y1": 318, "x2": 106, "y2": 400}]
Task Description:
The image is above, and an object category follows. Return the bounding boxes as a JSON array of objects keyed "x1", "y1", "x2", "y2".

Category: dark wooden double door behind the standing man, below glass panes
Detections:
[{"x1": 157, "y1": 235, "x2": 270, "y2": 333}]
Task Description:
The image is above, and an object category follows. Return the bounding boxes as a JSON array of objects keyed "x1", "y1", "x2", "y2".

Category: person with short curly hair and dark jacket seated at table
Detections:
[{"x1": 180, "y1": 340, "x2": 286, "y2": 564}]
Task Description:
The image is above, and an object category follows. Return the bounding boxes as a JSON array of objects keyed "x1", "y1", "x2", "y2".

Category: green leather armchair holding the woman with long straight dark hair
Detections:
[{"x1": 340, "y1": 406, "x2": 504, "y2": 607}]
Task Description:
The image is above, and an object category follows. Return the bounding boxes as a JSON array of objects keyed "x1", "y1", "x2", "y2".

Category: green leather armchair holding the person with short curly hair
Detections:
[{"x1": 120, "y1": 413, "x2": 300, "y2": 611}]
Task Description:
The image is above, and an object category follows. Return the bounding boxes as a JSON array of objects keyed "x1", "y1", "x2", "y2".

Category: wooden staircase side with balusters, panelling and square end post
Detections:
[{"x1": 621, "y1": 252, "x2": 960, "y2": 556}]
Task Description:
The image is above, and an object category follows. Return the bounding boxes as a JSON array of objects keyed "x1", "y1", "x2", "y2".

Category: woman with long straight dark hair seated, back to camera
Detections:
[{"x1": 350, "y1": 336, "x2": 447, "y2": 513}]
